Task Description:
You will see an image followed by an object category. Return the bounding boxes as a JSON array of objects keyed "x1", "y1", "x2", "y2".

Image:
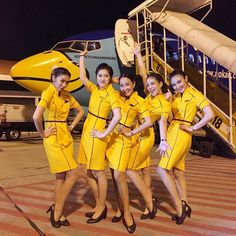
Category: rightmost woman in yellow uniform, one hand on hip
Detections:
[{"x1": 157, "y1": 70, "x2": 214, "y2": 224}]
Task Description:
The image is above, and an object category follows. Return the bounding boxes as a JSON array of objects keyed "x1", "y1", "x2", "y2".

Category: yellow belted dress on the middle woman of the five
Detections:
[{"x1": 106, "y1": 92, "x2": 150, "y2": 171}]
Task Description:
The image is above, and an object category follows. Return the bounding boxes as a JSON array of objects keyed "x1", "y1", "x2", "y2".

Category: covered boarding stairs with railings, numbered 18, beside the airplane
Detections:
[{"x1": 125, "y1": 0, "x2": 236, "y2": 157}]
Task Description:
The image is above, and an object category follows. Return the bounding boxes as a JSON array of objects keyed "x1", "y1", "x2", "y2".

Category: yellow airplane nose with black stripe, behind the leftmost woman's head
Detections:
[{"x1": 10, "y1": 51, "x2": 82, "y2": 94}]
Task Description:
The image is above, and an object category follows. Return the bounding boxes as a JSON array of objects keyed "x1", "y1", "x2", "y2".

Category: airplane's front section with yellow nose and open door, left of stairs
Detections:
[{"x1": 10, "y1": 19, "x2": 181, "y2": 107}]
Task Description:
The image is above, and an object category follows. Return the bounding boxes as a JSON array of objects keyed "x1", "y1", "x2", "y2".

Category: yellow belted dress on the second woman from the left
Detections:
[{"x1": 78, "y1": 81, "x2": 120, "y2": 170}]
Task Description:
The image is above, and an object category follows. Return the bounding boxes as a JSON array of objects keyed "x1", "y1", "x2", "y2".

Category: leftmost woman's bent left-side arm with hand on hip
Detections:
[{"x1": 33, "y1": 106, "x2": 57, "y2": 138}]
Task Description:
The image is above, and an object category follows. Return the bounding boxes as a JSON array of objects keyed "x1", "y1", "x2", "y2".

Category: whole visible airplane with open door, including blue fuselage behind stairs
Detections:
[{"x1": 10, "y1": 19, "x2": 236, "y2": 107}]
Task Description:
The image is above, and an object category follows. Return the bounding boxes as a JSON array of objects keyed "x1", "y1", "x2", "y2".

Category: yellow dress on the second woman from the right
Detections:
[{"x1": 127, "y1": 94, "x2": 171, "y2": 170}]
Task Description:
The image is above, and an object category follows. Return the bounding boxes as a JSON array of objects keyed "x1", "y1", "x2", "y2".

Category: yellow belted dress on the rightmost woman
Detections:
[{"x1": 159, "y1": 87, "x2": 209, "y2": 171}]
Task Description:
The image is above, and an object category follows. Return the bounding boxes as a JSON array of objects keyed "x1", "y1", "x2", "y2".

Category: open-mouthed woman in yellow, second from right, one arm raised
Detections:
[{"x1": 126, "y1": 45, "x2": 171, "y2": 219}]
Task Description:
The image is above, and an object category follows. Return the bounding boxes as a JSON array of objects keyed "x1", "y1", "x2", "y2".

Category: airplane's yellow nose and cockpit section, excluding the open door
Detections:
[{"x1": 11, "y1": 30, "x2": 125, "y2": 106}]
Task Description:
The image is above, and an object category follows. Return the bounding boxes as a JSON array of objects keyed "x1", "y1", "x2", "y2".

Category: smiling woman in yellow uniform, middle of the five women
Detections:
[{"x1": 106, "y1": 75, "x2": 156, "y2": 233}]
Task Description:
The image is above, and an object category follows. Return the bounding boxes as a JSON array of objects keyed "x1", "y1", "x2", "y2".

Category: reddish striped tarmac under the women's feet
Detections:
[{"x1": 0, "y1": 133, "x2": 236, "y2": 236}]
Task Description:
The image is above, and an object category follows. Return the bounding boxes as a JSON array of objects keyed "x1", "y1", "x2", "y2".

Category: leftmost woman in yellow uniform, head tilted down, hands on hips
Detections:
[{"x1": 33, "y1": 67, "x2": 84, "y2": 228}]
